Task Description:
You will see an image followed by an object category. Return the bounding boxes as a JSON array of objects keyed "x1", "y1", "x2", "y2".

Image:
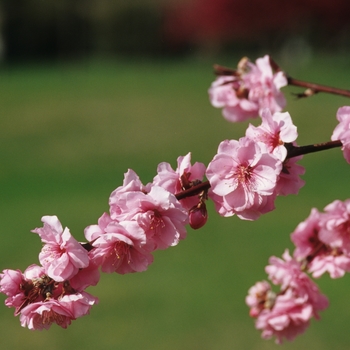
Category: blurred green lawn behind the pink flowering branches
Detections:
[{"x1": 0, "y1": 55, "x2": 350, "y2": 350}]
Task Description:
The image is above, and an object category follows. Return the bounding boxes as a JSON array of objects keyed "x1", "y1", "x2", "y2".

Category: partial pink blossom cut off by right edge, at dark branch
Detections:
[{"x1": 331, "y1": 106, "x2": 350, "y2": 163}]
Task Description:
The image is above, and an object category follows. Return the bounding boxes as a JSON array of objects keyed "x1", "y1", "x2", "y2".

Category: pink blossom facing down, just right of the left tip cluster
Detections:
[{"x1": 85, "y1": 216, "x2": 153, "y2": 274}]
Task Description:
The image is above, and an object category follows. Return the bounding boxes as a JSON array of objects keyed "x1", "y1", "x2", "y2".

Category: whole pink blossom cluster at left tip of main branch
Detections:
[{"x1": 0, "y1": 216, "x2": 100, "y2": 330}]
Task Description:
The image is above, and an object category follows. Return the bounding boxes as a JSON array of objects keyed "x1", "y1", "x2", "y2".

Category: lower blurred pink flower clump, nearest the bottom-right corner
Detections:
[{"x1": 246, "y1": 251, "x2": 328, "y2": 343}]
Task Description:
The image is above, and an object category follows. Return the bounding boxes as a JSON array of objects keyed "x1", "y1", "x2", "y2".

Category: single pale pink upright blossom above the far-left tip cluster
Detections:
[{"x1": 32, "y1": 216, "x2": 89, "y2": 282}]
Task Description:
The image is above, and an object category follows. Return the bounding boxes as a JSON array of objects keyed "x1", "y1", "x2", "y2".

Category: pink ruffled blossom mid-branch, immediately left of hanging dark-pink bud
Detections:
[{"x1": 109, "y1": 170, "x2": 188, "y2": 251}]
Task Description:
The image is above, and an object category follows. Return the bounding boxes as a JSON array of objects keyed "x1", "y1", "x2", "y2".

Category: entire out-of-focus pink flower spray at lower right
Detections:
[{"x1": 246, "y1": 199, "x2": 350, "y2": 343}]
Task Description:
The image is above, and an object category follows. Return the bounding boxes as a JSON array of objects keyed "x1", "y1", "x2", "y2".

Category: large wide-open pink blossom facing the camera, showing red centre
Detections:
[{"x1": 206, "y1": 138, "x2": 282, "y2": 220}]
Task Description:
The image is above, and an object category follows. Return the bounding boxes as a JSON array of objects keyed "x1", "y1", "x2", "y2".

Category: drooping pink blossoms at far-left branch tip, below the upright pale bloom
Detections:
[{"x1": 0, "y1": 265, "x2": 98, "y2": 330}]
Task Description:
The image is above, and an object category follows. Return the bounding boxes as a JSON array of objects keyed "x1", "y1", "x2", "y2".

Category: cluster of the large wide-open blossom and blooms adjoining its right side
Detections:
[{"x1": 206, "y1": 109, "x2": 304, "y2": 220}]
